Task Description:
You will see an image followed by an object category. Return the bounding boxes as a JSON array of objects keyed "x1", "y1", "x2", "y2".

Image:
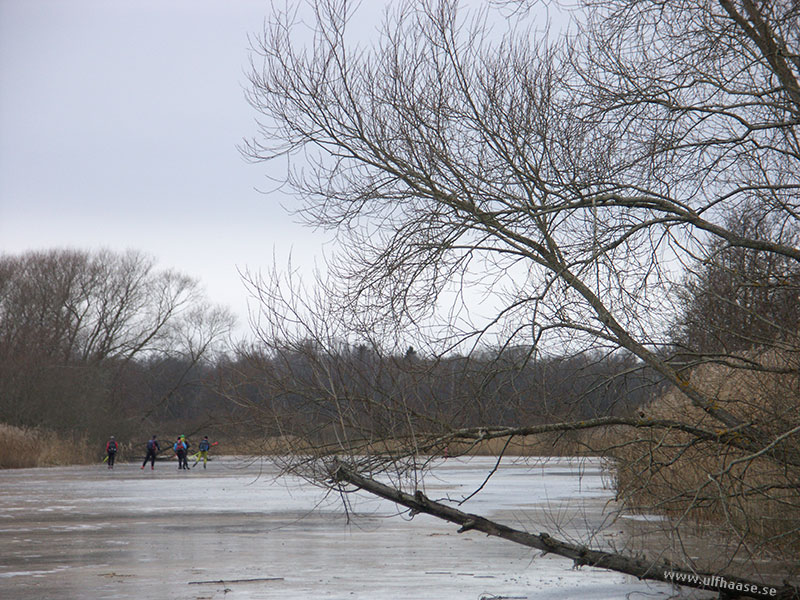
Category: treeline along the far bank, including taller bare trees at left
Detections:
[{"x1": 0, "y1": 250, "x2": 658, "y2": 452}]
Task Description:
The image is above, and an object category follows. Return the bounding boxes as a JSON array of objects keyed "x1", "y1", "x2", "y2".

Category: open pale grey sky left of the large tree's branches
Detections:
[{"x1": 0, "y1": 0, "x2": 340, "y2": 336}]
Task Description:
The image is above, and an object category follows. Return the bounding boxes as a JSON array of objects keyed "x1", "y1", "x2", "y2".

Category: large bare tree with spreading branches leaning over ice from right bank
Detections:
[{"x1": 245, "y1": 0, "x2": 800, "y2": 597}]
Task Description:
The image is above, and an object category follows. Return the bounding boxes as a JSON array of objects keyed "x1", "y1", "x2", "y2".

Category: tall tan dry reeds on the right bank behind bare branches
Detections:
[{"x1": 608, "y1": 357, "x2": 800, "y2": 559}]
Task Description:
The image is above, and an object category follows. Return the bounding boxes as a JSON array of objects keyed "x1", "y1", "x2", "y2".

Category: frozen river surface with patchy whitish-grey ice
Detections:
[{"x1": 0, "y1": 458, "x2": 688, "y2": 600}]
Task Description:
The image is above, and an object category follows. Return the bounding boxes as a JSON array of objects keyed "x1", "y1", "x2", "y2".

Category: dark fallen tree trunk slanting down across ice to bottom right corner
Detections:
[{"x1": 330, "y1": 462, "x2": 800, "y2": 600}]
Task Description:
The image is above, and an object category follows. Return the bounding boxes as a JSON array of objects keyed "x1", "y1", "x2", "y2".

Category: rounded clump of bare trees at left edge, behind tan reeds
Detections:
[{"x1": 0, "y1": 250, "x2": 233, "y2": 436}]
